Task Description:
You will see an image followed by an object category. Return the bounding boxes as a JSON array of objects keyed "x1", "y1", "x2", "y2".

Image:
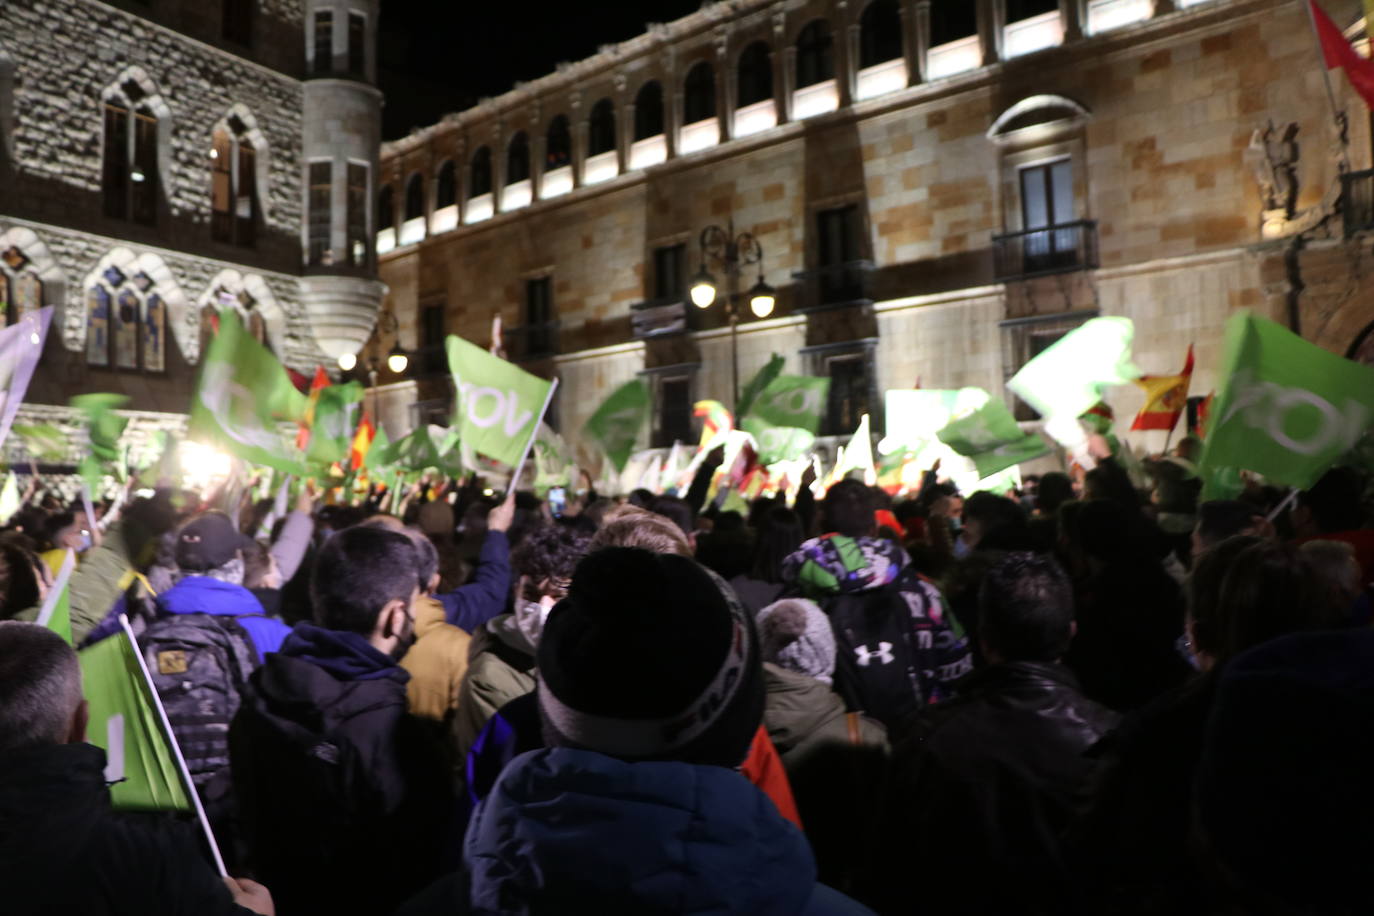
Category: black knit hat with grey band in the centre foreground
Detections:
[{"x1": 539, "y1": 548, "x2": 764, "y2": 766}]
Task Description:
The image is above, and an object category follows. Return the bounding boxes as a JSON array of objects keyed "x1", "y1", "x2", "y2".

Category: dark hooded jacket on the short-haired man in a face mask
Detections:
[{"x1": 229, "y1": 625, "x2": 453, "y2": 916}]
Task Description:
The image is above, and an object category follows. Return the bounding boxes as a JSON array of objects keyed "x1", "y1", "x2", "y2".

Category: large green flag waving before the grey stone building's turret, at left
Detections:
[{"x1": 188, "y1": 309, "x2": 308, "y2": 477}]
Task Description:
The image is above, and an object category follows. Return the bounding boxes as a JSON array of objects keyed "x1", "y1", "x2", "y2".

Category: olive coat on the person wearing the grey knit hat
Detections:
[{"x1": 764, "y1": 663, "x2": 888, "y2": 890}]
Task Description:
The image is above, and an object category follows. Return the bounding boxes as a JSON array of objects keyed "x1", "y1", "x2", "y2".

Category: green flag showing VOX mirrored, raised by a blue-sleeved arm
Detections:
[{"x1": 447, "y1": 335, "x2": 552, "y2": 467}]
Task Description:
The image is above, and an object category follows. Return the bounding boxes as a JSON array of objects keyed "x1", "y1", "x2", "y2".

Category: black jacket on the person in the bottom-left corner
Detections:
[{"x1": 0, "y1": 744, "x2": 250, "y2": 916}]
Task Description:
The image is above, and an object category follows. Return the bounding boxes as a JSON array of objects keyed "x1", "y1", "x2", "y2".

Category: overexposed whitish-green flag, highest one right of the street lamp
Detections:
[{"x1": 1007, "y1": 317, "x2": 1140, "y2": 417}]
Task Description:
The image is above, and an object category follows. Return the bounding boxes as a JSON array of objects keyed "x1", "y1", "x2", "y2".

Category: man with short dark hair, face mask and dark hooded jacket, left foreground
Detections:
[{"x1": 229, "y1": 527, "x2": 453, "y2": 915}]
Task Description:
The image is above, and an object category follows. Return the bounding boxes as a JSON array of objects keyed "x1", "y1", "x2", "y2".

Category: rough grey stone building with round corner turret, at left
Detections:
[{"x1": 0, "y1": 0, "x2": 382, "y2": 461}]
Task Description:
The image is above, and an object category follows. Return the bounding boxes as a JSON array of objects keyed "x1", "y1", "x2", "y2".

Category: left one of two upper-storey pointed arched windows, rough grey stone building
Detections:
[{"x1": 102, "y1": 78, "x2": 158, "y2": 225}]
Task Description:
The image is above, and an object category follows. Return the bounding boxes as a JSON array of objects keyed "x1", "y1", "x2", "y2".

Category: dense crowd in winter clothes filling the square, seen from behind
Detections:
[{"x1": 0, "y1": 441, "x2": 1374, "y2": 916}]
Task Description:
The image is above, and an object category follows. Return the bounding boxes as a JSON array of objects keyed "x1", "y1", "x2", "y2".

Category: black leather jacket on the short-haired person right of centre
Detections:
[{"x1": 874, "y1": 662, "x2": 1117, "y2": 915}]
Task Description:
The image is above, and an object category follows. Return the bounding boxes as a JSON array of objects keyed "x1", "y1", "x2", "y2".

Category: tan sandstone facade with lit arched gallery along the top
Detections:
[{"x1": 368, "y1": 0, "x2": 1374, "y2": 469}]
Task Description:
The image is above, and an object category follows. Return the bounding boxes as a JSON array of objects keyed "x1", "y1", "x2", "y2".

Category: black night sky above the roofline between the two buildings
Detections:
[{"x1": 378, "y1": 0, "x2": 702, "y2": 140}]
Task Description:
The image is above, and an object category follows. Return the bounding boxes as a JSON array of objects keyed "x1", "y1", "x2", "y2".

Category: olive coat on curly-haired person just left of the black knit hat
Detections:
[{"x1": 452, "y1": 614, "x2": 534, "y2": 761}]
